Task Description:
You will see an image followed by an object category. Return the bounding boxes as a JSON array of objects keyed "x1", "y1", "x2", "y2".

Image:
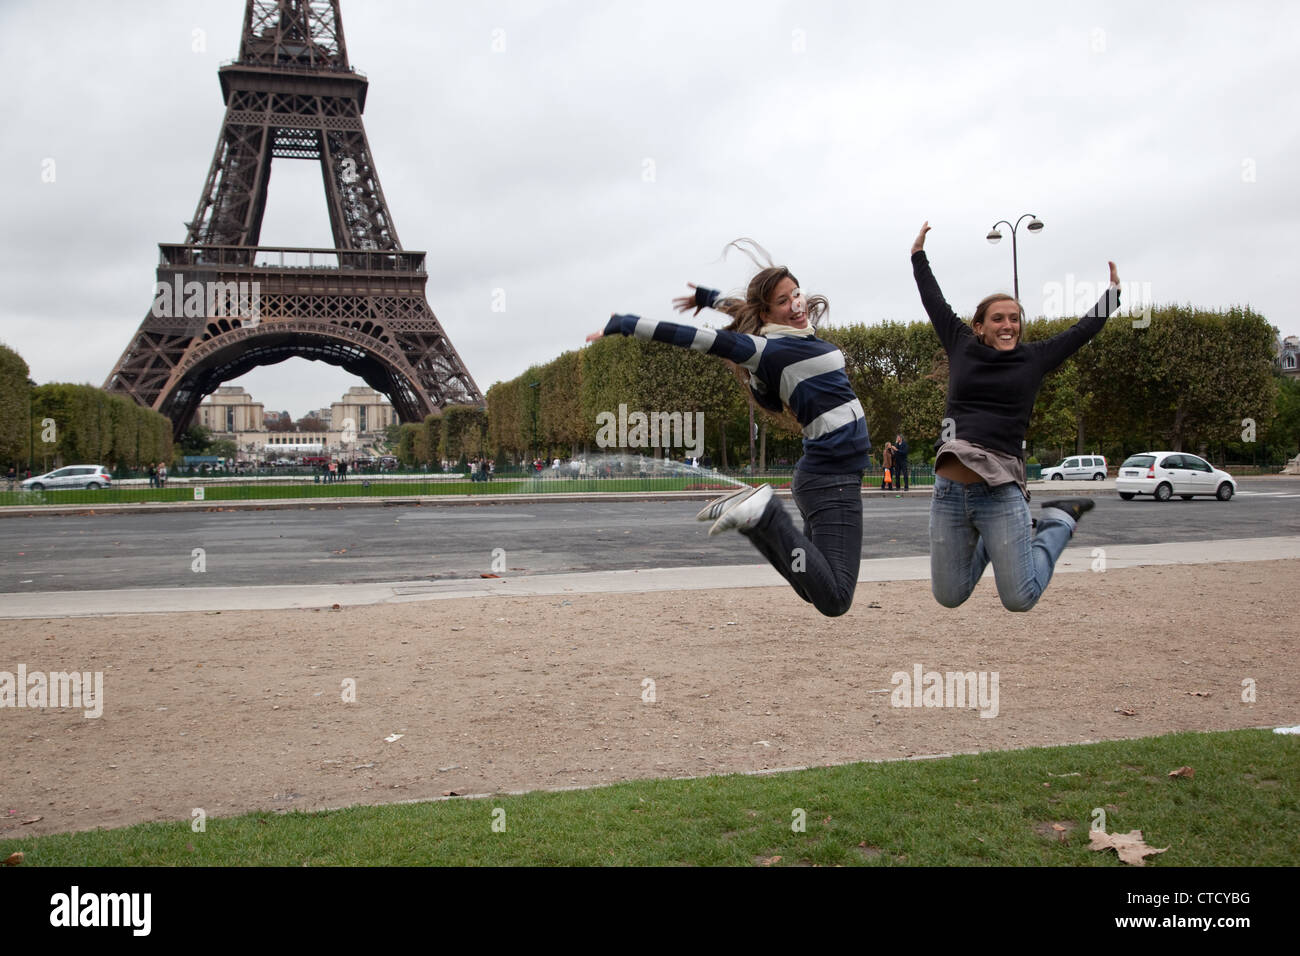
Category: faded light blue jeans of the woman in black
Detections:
[{"x1": 930, "y1": 475, "x2": 1074, "y2": 611}]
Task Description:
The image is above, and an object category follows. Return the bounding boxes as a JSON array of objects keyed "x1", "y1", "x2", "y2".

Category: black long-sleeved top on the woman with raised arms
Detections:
[{"x1": 911, "y1": 251, "x2": 1119, "y2": 458}]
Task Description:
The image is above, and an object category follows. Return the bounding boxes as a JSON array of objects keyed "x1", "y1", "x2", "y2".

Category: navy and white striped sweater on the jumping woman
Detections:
[{"x1": 605, "y1": 300, "x2": 871, "y2": 475}]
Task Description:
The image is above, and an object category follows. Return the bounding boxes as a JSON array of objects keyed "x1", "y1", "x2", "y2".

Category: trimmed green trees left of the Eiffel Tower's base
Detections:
[{"x1": 0, "y1": 346, "x2": 172, "y2": 473}]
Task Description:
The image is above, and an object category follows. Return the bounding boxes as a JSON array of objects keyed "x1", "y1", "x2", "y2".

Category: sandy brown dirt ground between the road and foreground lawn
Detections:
[{"x1": 0, "y1": 561, "x2": 1300, "y2": 838}]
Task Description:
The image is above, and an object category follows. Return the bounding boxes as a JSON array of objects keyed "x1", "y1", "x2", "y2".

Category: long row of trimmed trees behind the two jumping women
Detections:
[{"x1": 399, "y1": 306, "x2": 1300, "y2": 467}]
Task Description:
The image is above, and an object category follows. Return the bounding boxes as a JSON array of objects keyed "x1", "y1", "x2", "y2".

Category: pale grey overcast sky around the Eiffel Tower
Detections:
[{"x1": 0, "y1": 0, "x2": 1300, "y2": 416}]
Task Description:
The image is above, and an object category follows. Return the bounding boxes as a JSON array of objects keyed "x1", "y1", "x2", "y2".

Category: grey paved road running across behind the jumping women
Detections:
[{"x1": 0, "y1": 479, "x2": 1300, "y2": 593}]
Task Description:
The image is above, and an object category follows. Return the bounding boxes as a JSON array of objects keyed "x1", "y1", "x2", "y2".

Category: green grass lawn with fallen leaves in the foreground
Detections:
[{"x1": 0, "y1": 730, "x2": 1300, "y2": 868}]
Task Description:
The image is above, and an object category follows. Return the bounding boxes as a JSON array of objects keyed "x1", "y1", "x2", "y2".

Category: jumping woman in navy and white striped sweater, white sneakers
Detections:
[{"x1": 588, "y1": 243, "x2": 871, "y2": 617}]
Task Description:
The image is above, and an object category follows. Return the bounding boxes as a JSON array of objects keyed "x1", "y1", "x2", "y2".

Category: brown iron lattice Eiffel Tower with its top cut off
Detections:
[{"x1": 104, "y1": 0, "x2": 484, "y2": 437}]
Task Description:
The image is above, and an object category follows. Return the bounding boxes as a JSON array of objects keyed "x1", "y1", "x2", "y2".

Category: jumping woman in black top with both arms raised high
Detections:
[{"x1": 911, "y1": 222, "x2": 1119, "y2": 611}]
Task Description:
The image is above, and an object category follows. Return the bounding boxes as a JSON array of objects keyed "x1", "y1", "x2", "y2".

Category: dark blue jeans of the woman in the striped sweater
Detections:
[{"x1": 741, "y1": 470, "x2": 862, "y2": 618}]
